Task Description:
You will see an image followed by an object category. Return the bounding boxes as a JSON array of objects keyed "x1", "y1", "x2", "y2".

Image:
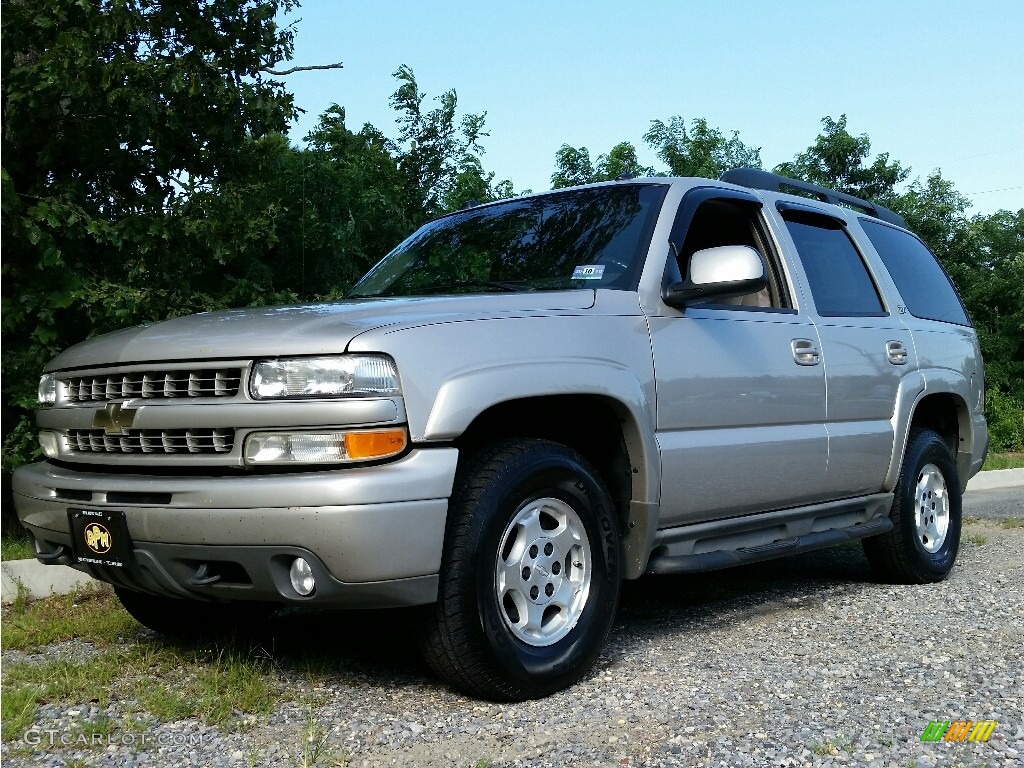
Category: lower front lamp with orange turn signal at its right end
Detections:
[{"x1": 246, "y1": 429, "x2": 408, "y2": 464}]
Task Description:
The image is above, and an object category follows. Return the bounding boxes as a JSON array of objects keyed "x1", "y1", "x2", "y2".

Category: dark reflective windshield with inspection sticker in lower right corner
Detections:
[{"x1": 348, "y1": 184, "x2": 668, "y2": 298}]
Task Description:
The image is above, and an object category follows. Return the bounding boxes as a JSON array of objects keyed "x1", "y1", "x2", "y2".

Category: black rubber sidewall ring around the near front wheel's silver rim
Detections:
[{"x1": 466, "y1": 441, "x2": 622, "y2": 695}]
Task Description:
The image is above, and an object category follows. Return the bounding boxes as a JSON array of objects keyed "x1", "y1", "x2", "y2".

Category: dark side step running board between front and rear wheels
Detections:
[{"x1": 647, "y1": 517, "x2": 893, "y2": 573}]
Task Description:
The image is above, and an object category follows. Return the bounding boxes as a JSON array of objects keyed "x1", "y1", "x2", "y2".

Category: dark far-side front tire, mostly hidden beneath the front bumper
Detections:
[{"x1": 114, "y1": 587, "x2": 274, "y2": 638}]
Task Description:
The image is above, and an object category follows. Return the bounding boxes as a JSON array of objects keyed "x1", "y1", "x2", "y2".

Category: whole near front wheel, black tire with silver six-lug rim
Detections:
[{"x1": 423, "y1": 439, "x2": 622, "y2": 701}]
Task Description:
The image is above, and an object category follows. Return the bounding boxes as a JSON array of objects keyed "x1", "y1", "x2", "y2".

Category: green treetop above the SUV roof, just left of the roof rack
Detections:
[{"x1": 644, "y1": 115, "x2": 761, "y2": 178}]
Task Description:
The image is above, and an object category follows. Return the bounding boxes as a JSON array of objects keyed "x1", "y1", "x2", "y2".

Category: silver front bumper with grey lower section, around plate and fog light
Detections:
[{"x1": 13, "y1": 447, "x2": 458, "y2": 607}]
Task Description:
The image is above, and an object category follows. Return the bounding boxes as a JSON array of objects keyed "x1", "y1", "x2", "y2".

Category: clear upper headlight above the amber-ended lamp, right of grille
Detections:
[{"x1": 249, "y1": 354, "x2": 401, "y2": 399}]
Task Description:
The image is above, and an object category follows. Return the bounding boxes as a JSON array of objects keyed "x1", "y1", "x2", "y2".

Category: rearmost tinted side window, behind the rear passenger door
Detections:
[{"x1": 860, "y1": 219, "x2": 971, "y2": 326}]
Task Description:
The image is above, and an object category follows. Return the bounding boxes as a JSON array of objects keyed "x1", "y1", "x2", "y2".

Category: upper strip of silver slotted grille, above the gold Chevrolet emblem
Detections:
[{"x1": 61, "y1": 368, "x2": 242, "y2": 402}]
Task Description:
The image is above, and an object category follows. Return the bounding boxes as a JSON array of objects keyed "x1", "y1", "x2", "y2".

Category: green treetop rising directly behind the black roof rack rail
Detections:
[{"x1": 775, "y1": 115, "x2": 910, "y2": 203}]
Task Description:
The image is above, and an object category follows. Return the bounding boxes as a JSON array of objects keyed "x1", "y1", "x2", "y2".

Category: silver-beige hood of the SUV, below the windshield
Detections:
[{"x1": 46, "y1": 290, "x2": 594, "y2": 371}]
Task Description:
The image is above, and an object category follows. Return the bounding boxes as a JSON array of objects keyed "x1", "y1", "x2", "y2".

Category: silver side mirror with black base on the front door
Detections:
[{"x1": 662, "y1": 246, "x2": 768, "y2": 309}]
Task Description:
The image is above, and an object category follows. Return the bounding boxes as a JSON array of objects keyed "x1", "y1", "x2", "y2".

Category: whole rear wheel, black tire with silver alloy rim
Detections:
[{"x1": 863, "y1": 429, "x2": 963, "y2": 584}]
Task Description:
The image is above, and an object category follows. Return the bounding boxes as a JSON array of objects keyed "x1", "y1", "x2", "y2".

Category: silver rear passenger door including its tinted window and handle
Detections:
[{"x1": 777, "y1": 202, "x2": 916, "y2": 498}]
